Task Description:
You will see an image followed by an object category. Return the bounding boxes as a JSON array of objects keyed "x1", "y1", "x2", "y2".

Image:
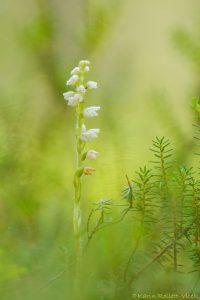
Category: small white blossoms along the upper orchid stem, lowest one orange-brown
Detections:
[{"x1": 63, "y1": 60, "x2": 100, "y2": 175}]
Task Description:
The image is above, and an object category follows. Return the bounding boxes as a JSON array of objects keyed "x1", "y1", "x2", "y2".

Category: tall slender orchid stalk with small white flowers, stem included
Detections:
[{"x1": 63, "y1": 60, "x2": 100, "y2": 266}]
